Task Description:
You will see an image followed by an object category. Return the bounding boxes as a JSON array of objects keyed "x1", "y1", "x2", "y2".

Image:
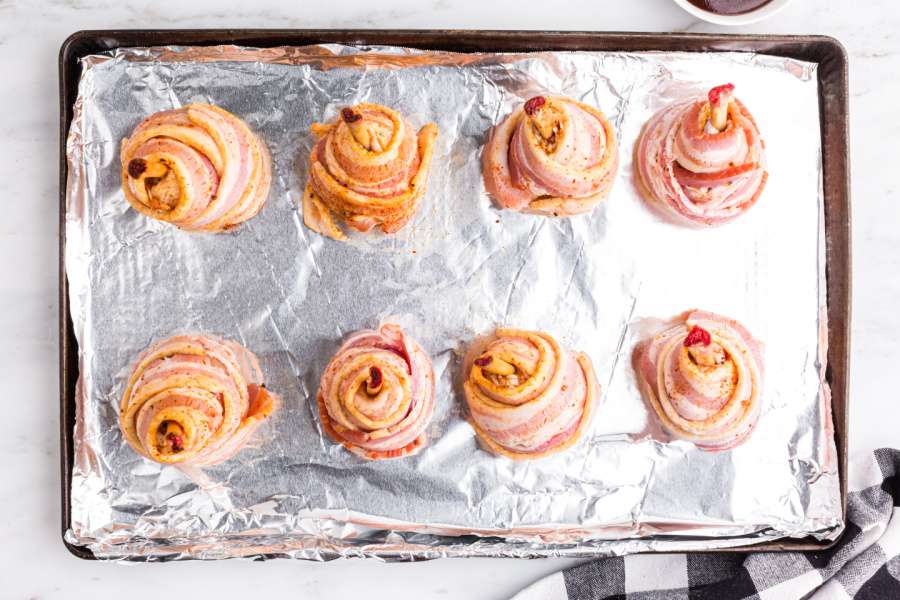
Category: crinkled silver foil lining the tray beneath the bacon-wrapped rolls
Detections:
[{"x1": 66, "y1": 46, "x2": 843, "y2": 559}]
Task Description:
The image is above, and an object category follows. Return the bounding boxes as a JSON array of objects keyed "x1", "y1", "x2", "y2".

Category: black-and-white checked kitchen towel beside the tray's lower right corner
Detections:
[{"x1": 513, "y1": 448, "x2": 900, "y2": 600}]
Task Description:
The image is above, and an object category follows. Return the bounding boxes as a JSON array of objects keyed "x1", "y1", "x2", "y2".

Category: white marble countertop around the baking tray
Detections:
[{"x1": 0, "y1": 0, "x2": 900, "y2": 600}]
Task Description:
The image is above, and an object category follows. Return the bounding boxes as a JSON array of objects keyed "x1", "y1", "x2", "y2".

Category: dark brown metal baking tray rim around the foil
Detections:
[{"x1": 59, "y1": 29, "x2": 851, "y2": 559}]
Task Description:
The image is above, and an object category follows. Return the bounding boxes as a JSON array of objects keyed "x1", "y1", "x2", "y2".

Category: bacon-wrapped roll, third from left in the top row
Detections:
[{"x1": 482, "y1": 96, "x2": 619, "y2": 216}]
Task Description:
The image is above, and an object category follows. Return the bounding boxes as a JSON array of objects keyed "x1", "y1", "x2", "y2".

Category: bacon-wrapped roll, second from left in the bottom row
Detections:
[{"x1": 316, "y1": 324, "x2": 434, "y2": 460}]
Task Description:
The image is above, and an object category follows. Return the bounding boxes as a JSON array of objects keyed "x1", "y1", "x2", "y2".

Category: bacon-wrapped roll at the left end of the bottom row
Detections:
[{"x1": 119, "y1": 335, "x2": 276, "y2": 465}]
